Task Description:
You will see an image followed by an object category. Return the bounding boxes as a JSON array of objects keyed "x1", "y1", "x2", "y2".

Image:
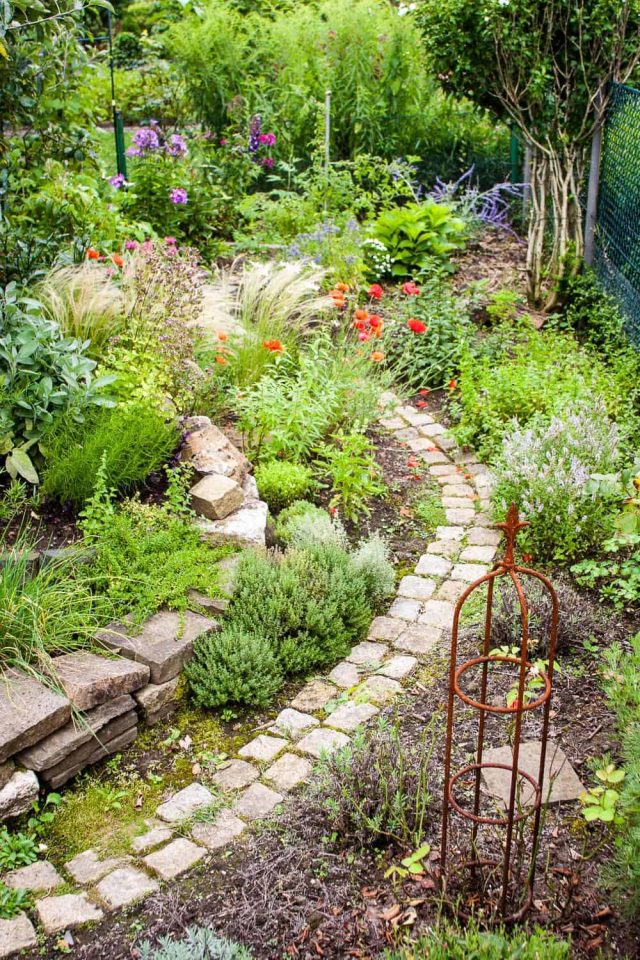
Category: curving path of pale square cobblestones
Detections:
[{"x1": 0, "y1": 394, "x2": 500, "y2": 957}]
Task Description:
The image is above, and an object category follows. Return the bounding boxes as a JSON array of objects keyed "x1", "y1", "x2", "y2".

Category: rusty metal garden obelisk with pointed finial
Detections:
[{"x1": 441, "y1": 504, "x2": 558, "y2": 922}]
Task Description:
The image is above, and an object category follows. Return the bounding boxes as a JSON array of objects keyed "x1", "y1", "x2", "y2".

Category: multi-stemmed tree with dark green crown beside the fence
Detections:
[{"x1": 418, "y1": 0, "x2": 640, "y2": 310}]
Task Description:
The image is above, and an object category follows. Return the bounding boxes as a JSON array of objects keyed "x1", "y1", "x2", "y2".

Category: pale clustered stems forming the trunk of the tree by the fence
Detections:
[{"x1": 527, "y1": 146, "x2": 585, "y2": 313}]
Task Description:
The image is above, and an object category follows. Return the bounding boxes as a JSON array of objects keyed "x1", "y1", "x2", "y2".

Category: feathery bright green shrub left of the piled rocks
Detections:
[{"x1": 42, "y1": 403, "x2": 180, "y2": 505}]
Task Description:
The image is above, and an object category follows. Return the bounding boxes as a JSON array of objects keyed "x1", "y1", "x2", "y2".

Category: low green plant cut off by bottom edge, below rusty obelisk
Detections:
[{"x1": 385, "y1": 923, "x2": 571, "y2": 960}]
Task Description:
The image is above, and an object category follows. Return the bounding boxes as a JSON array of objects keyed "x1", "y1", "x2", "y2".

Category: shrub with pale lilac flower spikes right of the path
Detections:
[{"x1": 492, "y1": 397, "x2": 619, "y2": 562}]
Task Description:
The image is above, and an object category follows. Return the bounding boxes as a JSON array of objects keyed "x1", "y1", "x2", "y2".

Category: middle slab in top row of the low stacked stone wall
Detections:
[{"x1": 53, "y1": 650, "x2": 149, "y2": 710}]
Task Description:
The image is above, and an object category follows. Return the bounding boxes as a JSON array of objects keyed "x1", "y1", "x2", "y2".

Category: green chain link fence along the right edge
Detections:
[{"x1": 593, "y1": 84, "x2": 640, "y2": 346}]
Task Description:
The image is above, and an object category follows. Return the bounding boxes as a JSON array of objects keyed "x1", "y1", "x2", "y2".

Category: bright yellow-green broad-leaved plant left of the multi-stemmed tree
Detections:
[{"x1": 373, "y1": 200, "x2": 466, "y2": 278}]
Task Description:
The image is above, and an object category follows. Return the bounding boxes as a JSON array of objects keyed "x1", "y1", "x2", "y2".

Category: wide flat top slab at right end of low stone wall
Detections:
[{"x1": 96, "y1": 610, "x2": 218, "y2": 692}]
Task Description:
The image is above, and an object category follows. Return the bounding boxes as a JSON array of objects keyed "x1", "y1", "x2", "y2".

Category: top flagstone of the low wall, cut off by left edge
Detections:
[{"x1": 0, "y1": 670, "x2": 71, "y2": 763}]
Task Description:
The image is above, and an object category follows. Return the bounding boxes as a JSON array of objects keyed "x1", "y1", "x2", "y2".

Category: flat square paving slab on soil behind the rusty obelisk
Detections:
[{"x1": 482, "y1": 740, "x2": 585, "y2": 807}]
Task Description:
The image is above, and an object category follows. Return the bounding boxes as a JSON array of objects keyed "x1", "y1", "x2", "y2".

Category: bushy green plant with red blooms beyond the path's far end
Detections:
[{"x1": 384, "y1": 281, "x2": 473, "y2": 390}]
